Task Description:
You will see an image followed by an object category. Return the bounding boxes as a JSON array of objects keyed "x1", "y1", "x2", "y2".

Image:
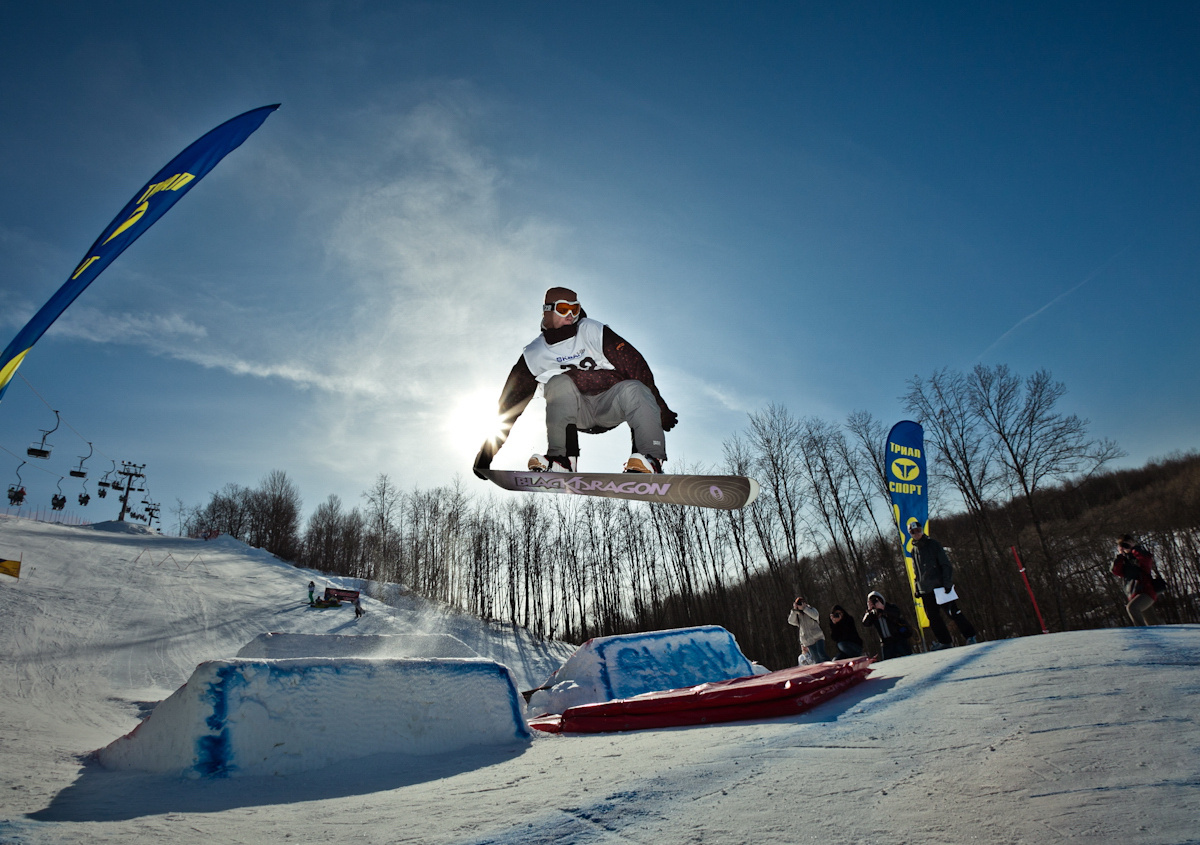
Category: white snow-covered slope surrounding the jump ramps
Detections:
[{"x1": 0, "y1": 519, "x2": 1200, "y2": 845}]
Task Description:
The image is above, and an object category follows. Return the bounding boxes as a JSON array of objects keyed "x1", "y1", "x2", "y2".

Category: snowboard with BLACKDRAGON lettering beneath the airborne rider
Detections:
[{"x1": 484, "y1": 469, "x2": 758, "y2": 510}]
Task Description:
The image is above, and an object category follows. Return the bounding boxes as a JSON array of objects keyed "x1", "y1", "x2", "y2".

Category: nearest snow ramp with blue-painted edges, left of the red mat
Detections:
[{"x1": 96, "y1": 658, "x2": 532, "y2": 778}]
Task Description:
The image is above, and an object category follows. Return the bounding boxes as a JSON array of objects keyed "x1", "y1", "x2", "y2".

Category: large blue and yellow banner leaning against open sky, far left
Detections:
[{"x1": 0, "y1": 103, "x2": 280, "y2": 398}]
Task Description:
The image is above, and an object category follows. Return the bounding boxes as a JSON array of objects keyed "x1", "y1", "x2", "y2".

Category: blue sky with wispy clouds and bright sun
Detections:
[{"x1": 0, "y1": 2, "x2": 1200, "y2": 522}]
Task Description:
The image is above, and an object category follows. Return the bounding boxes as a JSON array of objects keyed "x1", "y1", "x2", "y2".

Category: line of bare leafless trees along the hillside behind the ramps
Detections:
[{"x1": 181, "y1": 365, "x2": 1200, "y2": 669}]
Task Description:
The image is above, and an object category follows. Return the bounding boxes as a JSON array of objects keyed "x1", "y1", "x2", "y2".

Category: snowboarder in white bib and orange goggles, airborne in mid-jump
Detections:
[{"x1": 474, "y1": 287, "x2": 679, "y2": 478}]
